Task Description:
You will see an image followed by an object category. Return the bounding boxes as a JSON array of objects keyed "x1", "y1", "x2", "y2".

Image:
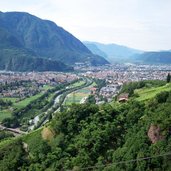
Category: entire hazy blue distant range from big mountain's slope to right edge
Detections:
[{"x1": 84, "y1": 41, "x2": 171, "y2": 64}]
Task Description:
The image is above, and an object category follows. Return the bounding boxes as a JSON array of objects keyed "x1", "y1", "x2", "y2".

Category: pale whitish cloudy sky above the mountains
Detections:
[{"x1": 0, "y1": 0, "x2": 171, "y2": 51}]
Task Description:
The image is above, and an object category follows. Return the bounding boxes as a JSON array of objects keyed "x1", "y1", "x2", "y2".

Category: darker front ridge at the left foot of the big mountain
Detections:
[{"x1": 0, "y1": 28, "x2": 73, "y2": 71}]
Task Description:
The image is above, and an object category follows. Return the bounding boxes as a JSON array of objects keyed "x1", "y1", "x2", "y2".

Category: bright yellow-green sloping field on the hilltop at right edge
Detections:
[{"x1": 135, "y1": 84, "x2": 171, "y2": 101}]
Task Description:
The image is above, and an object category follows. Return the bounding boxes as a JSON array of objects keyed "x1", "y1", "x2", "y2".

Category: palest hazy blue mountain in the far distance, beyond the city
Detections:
[{"x1": 83, "y1": 41, "x2": 143, "y2": 62}]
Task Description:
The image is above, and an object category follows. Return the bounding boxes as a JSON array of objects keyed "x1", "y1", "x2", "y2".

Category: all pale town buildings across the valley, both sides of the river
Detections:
[{"x1": 0, "y1": 63, "x2": 171, "y2": 101}]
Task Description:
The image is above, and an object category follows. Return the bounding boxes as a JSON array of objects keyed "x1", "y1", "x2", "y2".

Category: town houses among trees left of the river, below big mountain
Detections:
[{"x1": 0, "y1": 72, "x2": 78, "y2": 99}]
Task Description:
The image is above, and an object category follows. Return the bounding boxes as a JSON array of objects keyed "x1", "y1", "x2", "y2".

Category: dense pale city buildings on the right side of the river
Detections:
[{"x1": 82, "y1": 64, "x2": 171, "y2": 101}]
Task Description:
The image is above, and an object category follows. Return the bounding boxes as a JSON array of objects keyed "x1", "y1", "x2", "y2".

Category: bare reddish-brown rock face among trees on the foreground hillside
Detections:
[{"x1": 148, "y1": 125, "x2": 164, "y2": 144}]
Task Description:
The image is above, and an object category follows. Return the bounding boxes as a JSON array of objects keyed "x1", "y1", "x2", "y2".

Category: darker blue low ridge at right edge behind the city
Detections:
[{"x1": 132, "y1": 51, "x2": 171, "y2": 64}]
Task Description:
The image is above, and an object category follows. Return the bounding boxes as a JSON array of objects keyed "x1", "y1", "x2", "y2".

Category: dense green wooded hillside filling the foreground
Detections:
[{"x1": 0, "y1": 81, "x2": 171, "y2": 171}]
